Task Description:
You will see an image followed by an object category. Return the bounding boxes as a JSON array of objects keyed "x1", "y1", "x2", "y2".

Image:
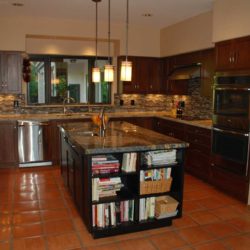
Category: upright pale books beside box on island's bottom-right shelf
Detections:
[{"x1": 139, "y1": 197, "x2": 155, "y2": 221}]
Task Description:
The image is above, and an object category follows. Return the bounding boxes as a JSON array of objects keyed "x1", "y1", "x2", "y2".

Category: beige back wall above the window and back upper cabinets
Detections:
[{"x1": 0, "y1": 17, "x2": 160, "y2": 56}]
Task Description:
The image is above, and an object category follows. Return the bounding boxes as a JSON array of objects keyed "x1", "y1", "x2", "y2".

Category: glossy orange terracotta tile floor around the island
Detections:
[{"x1": 0, "y1": 167, "x2": 250, "y2": 250}]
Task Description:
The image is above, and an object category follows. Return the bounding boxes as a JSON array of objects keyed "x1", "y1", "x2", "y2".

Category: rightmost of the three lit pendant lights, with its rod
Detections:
[{"x1": 120, "y1": 0, "x2": 132, "y2": 82}]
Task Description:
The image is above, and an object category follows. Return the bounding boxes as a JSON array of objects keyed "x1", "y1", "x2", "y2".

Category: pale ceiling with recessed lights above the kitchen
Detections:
[{"x1": 0, "y1": 0, "x2": 214, "y2": 28}]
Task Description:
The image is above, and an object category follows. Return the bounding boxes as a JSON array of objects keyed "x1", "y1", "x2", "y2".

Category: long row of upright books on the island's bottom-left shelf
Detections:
[{"x1": 92, "y1": 200, "x2": 134, "y2": 228}]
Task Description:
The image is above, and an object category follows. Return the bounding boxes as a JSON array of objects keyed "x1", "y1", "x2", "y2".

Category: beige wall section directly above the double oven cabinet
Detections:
[{"x1": 213, "y1": 0, "x2": 250, "y2": 42}]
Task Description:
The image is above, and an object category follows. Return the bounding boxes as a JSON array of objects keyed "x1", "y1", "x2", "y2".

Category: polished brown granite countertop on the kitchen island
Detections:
[{"x1": 60, "y1": 121, "x2": 189, "y2": 154}]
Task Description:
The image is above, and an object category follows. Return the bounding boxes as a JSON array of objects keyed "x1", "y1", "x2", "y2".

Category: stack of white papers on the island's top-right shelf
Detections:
[{"x1": 143, "y1": 149, "x2": 177, "y2": 166}]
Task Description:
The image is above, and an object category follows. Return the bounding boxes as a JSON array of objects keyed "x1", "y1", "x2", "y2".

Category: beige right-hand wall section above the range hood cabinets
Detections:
[{"x1": 160, "y1": 12, "x2": 214, "y2": 56}]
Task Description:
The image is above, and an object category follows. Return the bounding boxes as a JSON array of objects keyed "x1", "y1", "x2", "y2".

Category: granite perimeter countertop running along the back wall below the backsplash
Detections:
[{"x1": 0, "y1": 111, "x2": 212, "y2": 129}]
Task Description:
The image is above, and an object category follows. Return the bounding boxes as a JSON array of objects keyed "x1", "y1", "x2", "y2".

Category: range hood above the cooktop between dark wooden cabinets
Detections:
[{"x1": 168, "y1": 63, "x2": 201, "y2": 80}]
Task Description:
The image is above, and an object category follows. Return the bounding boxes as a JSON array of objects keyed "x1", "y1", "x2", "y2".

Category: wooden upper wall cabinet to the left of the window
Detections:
[{"x1": 0, "y1": 52, "x2": 22, "y2": 94}]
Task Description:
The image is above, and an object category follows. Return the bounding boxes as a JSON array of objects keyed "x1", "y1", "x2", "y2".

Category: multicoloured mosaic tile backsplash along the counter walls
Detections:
[{"x1": 0, "y1": 79, "x2": 212, "y2": 118}]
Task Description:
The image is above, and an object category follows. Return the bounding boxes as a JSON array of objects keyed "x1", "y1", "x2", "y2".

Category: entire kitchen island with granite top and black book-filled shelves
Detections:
[{"x1": 60, "y1": 121, "x2": 188, "y2": 238}]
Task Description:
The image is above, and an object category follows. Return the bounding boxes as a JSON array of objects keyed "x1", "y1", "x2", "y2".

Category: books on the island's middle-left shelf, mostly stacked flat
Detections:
[{"x1": 92, "y1": 177, "x2": 124, "y2": 201}]
